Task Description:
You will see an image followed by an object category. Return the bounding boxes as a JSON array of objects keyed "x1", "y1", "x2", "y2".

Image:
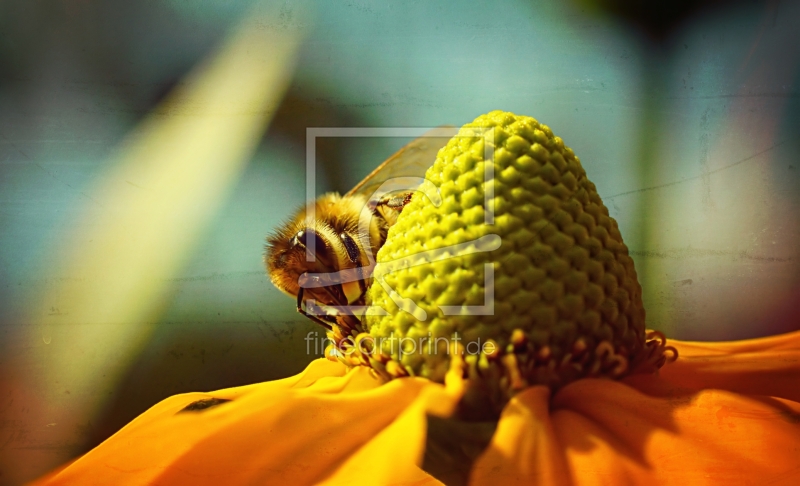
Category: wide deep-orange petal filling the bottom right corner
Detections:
[{"x1": 542, "y1": 376, "x2": 800, "y2": 485}]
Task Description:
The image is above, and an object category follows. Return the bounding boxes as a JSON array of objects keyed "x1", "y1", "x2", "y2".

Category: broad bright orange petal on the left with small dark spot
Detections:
[{"x1": 31, "y1": 361, "x2": 434, "y2": 485}]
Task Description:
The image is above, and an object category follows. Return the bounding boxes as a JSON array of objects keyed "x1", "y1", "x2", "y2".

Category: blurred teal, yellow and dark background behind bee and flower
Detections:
[{"x1": 0, "y1": 0, "x2": 800, "y2": 484}]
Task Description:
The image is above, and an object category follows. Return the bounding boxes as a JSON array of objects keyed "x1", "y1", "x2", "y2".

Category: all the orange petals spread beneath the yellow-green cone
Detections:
[{"x1": 28, "y1": 331, "x2": 800, "y2": 486}]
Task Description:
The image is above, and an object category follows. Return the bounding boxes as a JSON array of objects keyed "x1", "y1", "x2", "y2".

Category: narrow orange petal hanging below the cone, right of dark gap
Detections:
[{"x1": 471, "y1": 386, "x2": 571, "y2": 486}]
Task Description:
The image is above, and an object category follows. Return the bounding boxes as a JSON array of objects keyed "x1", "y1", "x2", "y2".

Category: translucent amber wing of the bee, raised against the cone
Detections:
[{"x1": 345, "y1": 126, "x2": 458, "y2": 199}]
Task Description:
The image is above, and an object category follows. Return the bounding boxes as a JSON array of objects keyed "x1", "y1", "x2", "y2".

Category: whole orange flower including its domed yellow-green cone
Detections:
[{"x1": 29, "y1": 112, "x2": 800, "y2": 486}]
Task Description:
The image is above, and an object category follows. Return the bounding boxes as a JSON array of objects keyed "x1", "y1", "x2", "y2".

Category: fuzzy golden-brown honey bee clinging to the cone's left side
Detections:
[{"x1": 264, "y1": 127, "x2": 456, "y2": 330}]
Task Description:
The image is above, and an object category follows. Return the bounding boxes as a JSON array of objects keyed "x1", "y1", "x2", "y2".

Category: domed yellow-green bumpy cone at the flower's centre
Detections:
[{"x1": 365, "y1": 111, "x2": 645, "y2": 402}]
